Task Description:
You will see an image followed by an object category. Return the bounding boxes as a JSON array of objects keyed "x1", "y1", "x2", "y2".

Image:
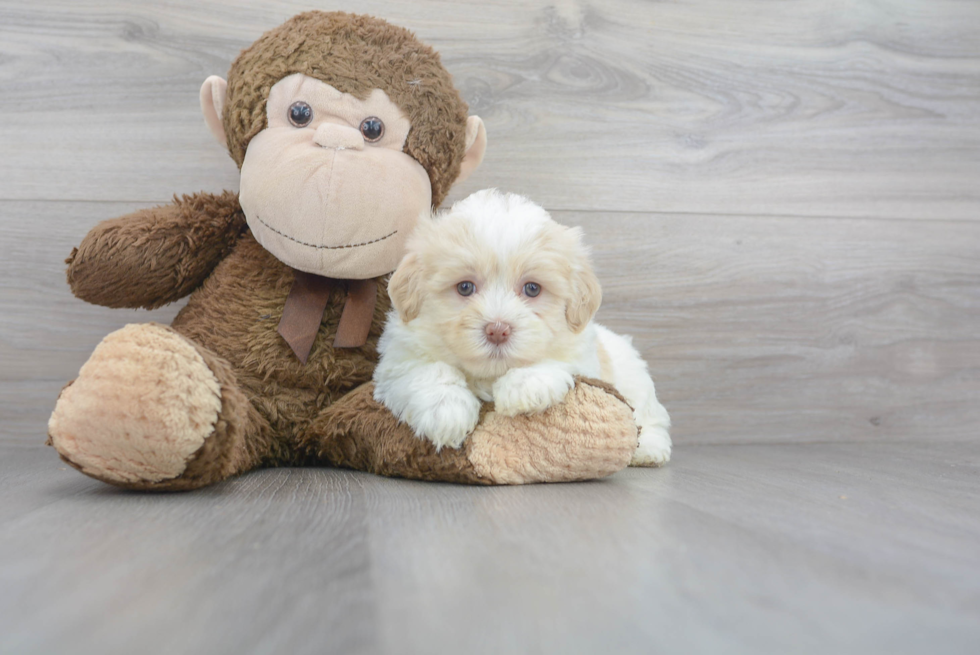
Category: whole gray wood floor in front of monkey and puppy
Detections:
[{"x1": 0, "y1": 443, "x2": 980, "y2": 655}]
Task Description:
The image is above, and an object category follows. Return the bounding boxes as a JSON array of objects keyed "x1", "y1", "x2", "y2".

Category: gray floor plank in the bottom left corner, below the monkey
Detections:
[{"x1": 0, "y1": 449, "x2": 377, "y2": 653}]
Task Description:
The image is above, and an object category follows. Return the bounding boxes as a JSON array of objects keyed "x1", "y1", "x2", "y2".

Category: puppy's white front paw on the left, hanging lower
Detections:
[{"x1": 405, "y1": 386, "x2": 480, "y2": 451}]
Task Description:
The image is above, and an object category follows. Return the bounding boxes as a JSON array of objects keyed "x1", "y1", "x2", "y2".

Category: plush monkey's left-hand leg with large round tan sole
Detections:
[{"x1": 48, "y1": 323, "x2": 268, "y2": 490}]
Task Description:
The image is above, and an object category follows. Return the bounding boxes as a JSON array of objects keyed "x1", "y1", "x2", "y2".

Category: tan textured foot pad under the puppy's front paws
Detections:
[{"x1": 468, "y1": 381, "x2": 637, "y2": 484}]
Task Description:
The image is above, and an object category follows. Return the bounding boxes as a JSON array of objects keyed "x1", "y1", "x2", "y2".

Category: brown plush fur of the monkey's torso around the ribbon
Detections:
[{"x1": 173, "y1": 218, "x2": 391, "y2": 463}]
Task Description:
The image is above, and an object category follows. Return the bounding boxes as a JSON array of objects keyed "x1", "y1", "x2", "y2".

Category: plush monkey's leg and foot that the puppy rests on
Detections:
[{"x1": 300, "y1": 379, "x2": 637, "y2": 484}]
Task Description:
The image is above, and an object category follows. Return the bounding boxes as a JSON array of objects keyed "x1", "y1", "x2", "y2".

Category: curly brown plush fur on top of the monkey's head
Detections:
[{"x1": 223, "y1": 11, "x2": 468, "y2": 206}]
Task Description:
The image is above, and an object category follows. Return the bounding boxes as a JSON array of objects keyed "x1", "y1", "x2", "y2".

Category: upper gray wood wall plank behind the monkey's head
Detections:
[{"x1": 0, "y1": 0, "x2": 980, "y2": 220}]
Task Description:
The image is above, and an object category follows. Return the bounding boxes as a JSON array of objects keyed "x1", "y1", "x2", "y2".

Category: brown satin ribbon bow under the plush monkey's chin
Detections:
[{"x1": 276, "y1": 270, "x2": 378, "y2": 364}]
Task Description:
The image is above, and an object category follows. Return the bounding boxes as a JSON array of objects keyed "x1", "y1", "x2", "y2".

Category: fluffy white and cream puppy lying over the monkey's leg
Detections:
[{"x1": 374, "y1": 189, "x2": 671, "y2": 466}]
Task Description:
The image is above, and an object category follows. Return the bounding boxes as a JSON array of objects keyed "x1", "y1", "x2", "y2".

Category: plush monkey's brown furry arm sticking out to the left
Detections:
[{"x1": 65, "y1": 191, "x2": 245, "y2": 309}]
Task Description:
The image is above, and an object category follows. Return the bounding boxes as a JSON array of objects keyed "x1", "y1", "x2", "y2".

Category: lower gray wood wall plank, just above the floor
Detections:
[{"x1": 0, "y1": 201, "x2": 980, "y2": 443}]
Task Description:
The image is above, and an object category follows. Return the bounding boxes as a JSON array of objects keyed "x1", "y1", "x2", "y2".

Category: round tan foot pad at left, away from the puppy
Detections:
[{"x1": 48, "y1": 323, "x2": 221, "y2": 482}]
